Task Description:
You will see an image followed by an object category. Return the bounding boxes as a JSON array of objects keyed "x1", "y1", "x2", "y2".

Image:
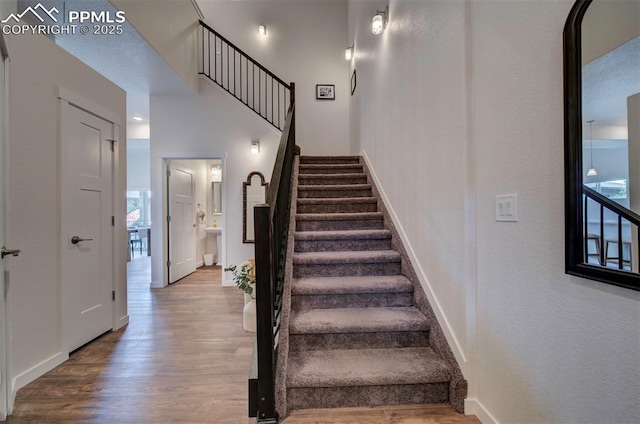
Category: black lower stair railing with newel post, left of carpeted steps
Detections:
[{"x1": 254, "y1": 88, "x2": 296, "y2": 424}]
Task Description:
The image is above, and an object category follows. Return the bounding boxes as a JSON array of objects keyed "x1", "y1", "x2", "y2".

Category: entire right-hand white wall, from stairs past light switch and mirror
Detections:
[{"x1": 349, "y1": 0, "x2": 640, "y2": 423}]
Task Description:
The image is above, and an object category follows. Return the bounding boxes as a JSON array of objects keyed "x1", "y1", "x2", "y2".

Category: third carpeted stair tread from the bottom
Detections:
[{"x1": 291, "y1": 275, "x2": 413, "y2": 296}]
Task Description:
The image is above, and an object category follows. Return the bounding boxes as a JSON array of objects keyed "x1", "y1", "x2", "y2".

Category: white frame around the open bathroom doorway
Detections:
[{"x1": 151, "y1": 156, "x2": 227, "y2": 288}]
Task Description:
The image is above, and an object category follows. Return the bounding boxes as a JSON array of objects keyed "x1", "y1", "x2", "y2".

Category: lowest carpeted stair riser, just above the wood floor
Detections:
[{"x1": 287, "y1": 383, "x2": 449, "y2": 409}]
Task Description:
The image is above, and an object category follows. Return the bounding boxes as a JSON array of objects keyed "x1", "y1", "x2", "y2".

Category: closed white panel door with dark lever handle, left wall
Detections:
[{"x1": 61, "y1": 101, "x2": 114, "y2": 352}]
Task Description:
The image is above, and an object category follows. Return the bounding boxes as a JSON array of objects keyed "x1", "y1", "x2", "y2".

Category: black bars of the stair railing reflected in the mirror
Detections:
[{"x1": 582, "y1": 186, "x2": 640, "y2": 274}]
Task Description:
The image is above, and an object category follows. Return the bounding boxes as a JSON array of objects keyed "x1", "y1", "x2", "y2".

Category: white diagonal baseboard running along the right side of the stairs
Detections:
[{"x1": 362, "y1": 151, "x2": 468, "y2": 372}]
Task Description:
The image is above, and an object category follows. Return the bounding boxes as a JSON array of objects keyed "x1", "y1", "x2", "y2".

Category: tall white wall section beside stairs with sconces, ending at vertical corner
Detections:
[{"x1": 349, "y1": 1, "x2": 469, "y2": 368}]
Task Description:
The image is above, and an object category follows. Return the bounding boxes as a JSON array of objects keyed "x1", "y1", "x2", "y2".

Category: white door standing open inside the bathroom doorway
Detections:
[{"x1": 168, "y1": 162, "x2": 196, "y2": 284}]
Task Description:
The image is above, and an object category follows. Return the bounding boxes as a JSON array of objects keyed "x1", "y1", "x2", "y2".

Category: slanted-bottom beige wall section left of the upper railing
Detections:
[{"x1": 110, "y1": 0, "x2": 200, "y2": 90}]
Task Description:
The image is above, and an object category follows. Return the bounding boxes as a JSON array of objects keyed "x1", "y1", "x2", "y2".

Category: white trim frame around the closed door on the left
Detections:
[{"x1": 57, "y1": 86, "x2": 129, "y2": 353}]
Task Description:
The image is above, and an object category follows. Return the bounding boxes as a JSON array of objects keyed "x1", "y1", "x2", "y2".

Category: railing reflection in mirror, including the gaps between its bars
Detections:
[{"x1": 582, "y1": 186, "x2": 640, "y2": 274}]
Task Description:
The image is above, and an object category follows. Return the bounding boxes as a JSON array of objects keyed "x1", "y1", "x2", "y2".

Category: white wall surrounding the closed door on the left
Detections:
[{"x1": 7, "y1": 35, "x2": 127, "y2": 396}]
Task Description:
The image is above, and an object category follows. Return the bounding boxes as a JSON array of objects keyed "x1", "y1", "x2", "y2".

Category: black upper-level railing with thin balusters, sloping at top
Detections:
[{"x1": 199, "y1": 21, "x2": 291, "y2": 131}]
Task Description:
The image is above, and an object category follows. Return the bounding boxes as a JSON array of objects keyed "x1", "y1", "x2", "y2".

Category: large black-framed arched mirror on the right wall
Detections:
[{"x1": 563, "y1": 0, "x2": 640, "y2": 290}]
